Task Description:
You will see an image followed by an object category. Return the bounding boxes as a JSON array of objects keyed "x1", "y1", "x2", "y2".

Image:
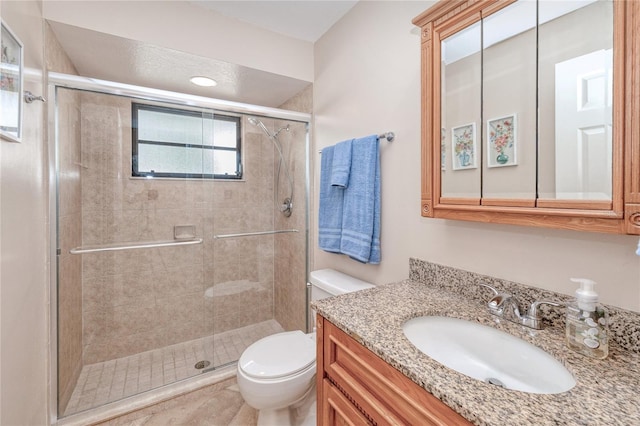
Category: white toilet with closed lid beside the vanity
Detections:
[{"x1": 237, "y1": 269, "x2": 373, "y2": 426}]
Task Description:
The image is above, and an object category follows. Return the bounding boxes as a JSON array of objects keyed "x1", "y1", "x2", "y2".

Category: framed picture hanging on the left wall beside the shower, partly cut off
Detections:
[{"x1": 0, "y1": 22, "x2": 24, "y2": 142}]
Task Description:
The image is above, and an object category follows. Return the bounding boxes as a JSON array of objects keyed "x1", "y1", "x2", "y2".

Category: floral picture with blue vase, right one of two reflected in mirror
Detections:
[{"x1": 487, "y1": 113, "x2": 518, "y2": 167}]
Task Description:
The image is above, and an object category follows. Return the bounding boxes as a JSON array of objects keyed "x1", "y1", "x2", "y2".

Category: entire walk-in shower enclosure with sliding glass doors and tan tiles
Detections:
[{"x1": 50, "y1": 75, "x2": 309, "y2": 417}]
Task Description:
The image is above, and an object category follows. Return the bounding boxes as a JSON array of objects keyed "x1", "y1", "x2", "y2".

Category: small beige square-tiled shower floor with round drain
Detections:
[{"x1": 64, "y1": 320, "x2": 284, "y2": 416}]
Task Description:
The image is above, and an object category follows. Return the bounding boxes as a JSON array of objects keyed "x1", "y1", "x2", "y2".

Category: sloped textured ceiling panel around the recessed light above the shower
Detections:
[{"x1": 49, "y1": 22, "x2": 309, "y2": 107}]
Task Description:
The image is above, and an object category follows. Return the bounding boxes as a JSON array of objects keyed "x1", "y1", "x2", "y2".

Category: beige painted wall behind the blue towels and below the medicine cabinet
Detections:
[{"x1": 312, "y1": 1, "x2": 640, "y2": 311}]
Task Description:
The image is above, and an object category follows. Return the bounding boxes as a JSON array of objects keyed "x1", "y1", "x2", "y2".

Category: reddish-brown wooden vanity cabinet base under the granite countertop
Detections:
[{"x1": 316, "y1": 315, "x2": 471, "y2": 426}]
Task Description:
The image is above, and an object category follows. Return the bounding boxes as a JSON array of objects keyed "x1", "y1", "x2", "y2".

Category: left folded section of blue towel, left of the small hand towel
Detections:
[{"x1": 318, "y1": 146, "x2": 344, "y2": 253}]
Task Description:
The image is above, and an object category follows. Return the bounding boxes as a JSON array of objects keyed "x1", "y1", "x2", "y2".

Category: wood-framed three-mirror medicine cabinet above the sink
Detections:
[{"x1": 413, "y1": 0, "x2": 640, "y2": 234}]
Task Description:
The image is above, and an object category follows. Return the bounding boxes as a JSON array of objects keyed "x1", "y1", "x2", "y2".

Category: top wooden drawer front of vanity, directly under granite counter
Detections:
[{"x1": 322, "y1": 320, "x2": 471, "y2": 426}]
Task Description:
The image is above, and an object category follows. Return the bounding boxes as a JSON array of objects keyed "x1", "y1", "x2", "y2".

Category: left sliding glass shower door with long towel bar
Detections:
[{"x1": 56, "y1": 88, "x2": 213, "y2": 415}]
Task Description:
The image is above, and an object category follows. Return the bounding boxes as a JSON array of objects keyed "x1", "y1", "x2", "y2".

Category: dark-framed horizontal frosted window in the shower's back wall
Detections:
[{"x1": 131, "y1": 103, "x2": 242, "y2": 179}]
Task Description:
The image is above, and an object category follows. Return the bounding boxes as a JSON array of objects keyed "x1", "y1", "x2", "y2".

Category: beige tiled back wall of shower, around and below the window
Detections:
[{"x1": 75, "y1": 93, "x2": 292, "y2": 364}]
